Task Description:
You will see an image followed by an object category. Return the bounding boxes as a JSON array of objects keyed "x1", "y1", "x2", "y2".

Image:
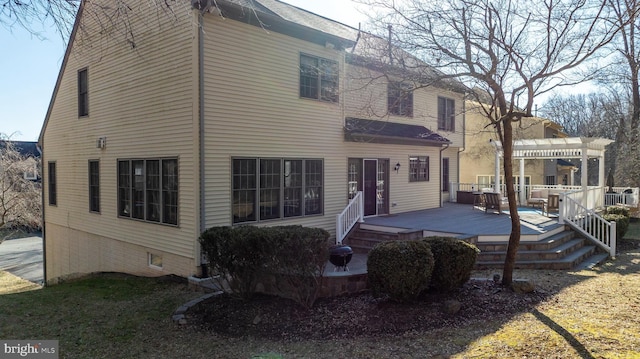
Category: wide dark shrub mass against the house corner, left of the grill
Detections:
[{"x1": 200, "y1": 226, "x2": 329, "y2": 307}]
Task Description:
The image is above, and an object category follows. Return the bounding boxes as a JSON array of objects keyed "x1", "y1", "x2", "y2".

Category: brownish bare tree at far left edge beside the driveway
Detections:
[{"x1": 0, "y1": 134, "x2": 42, "y2": 242}]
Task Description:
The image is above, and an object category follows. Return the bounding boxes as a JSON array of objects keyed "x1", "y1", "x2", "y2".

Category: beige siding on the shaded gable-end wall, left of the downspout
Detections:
[{"x1": 43, "y1": 1, "x2": 199, "y2": 270}]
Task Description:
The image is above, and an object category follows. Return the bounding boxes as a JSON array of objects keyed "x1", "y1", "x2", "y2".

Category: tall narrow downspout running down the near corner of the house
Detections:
[{"x1": 198, "y1": 11, "x2": 207, "y2": 276}]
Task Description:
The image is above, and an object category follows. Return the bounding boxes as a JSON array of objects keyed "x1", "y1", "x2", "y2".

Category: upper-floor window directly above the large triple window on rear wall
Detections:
[{"x1": 300, "y1": 54, "x2": 338, "y2": 102}]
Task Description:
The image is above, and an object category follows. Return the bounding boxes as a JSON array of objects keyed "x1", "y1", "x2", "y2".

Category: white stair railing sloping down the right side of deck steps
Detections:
[{"x1": 560, "y1": 191, "x2": 616, "y2": 257}]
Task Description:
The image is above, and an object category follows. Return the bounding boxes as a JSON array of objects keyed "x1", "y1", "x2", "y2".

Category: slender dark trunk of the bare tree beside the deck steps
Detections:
[{"x1": 502, "y1": 116, "x2": 520, "y2": 285}]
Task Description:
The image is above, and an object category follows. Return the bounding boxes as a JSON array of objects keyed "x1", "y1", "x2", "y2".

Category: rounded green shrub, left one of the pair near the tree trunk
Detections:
[{"x1": 367, "y1": 241, "x2": 434, "y2": 302}]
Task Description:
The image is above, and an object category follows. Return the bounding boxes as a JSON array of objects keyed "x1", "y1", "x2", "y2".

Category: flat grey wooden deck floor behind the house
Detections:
[{"x1": 363, "y1": 202, "x2": 564, "y2": 241}]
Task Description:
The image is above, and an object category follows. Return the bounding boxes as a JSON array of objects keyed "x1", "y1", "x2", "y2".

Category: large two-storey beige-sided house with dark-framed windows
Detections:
[{"x1": 39, "y1": 0, "x2": 464, "y2": 283}]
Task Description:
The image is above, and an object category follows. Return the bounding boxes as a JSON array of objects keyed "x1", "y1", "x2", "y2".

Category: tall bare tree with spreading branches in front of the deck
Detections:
[{"x1": 360, "y1": 0, "x2": 618, "y2": 285}]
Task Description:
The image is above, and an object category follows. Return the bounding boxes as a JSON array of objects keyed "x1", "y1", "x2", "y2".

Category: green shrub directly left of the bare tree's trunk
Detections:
[{"x1": 425, "y1": 237, "x2": 480, "y2": 291}]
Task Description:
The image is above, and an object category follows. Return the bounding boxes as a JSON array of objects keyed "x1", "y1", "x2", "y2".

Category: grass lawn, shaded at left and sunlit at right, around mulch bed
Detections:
[{"x1": 0, "y1": 245, "x2": 640, "y2": 359}]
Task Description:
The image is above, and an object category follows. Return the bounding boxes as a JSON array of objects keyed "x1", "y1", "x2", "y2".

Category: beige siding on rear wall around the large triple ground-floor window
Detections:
[{"x1": 204, "y1": 16, "x2": 347, "y2": 235}]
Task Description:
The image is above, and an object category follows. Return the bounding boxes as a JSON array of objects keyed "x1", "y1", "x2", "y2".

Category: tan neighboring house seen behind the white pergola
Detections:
[{"x1": 460, "y1": 101, "x2": 576, "y2": 188}]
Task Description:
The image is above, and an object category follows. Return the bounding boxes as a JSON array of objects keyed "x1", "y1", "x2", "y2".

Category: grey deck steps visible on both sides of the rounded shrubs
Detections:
[{"x1": 344, "y1": 227, "x2": 607, "y2": 269}]
